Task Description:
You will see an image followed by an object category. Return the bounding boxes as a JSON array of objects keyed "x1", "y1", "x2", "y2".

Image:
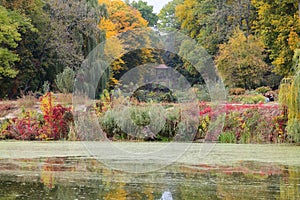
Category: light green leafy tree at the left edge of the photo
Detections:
[{"x1": 0, "y1": 6, "x2": 33, "y2": 80}]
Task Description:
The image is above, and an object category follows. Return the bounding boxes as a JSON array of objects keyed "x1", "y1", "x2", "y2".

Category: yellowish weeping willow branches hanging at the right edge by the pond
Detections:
[{"x1": 279, "y1": 49, "x2": 300, "y2": 142}]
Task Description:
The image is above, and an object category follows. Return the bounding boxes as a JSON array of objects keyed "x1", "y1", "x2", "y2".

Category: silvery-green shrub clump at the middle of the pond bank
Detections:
[{"x1": 99, "y1": 104, "x2": 180, "y2": 141}]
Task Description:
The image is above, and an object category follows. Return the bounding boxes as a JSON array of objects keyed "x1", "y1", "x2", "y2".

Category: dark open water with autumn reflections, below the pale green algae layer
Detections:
[{"x1": 0, "y1": 157, "x2": 300, "y2": 200}]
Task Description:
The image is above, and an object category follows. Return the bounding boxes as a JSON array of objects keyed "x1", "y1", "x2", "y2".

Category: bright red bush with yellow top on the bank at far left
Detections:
[{"x1": 0, "y1": 93, "x2": 71, "y2": 140}]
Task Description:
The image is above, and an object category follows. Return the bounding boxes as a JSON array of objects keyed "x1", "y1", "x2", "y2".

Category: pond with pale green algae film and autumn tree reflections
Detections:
[{"x1": 0, "y1": 142, "x2": 300, "y2": 200}]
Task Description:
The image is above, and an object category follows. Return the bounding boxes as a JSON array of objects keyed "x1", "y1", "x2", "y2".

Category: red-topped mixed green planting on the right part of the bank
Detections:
[{"x1": 197, "y1": 102, "x2": 287, "y2": 143}]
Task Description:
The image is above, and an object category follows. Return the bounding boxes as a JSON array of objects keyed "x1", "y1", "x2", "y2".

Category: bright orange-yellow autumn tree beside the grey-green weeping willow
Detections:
[{"x1": 99, "y1": 0, "x2": 154, "y2": 87}]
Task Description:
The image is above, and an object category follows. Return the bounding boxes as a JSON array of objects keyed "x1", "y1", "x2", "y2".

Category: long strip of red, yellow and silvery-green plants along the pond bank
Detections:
[{"x1": 0, "y1": 93, "x2": 289, "y2": 143}]
